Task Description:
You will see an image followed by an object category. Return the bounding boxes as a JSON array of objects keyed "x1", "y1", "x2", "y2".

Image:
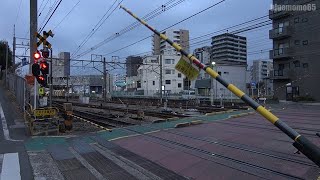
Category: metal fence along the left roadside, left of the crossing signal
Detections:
[{"x1": 6, "y1": 74, "x2": 30, "y2": 110}]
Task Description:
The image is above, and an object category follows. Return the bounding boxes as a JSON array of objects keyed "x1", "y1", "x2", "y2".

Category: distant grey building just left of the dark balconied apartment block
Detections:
[{"x1": 251, "y1": 60, "x2": 273, "y2": 96}]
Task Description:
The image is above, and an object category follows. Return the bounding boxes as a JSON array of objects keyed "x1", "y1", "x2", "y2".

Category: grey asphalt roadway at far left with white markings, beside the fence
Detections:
[{"x1": 0, "y1": 82, "x2": 33, "y2": 180}]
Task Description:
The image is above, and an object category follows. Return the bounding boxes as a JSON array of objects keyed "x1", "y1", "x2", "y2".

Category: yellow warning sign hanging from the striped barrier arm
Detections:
[{"x1": 175, "y1": 56, "x2": 200, "y2": 80}]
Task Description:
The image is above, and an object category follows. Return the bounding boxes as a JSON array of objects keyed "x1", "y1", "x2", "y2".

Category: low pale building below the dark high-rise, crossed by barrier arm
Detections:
[{"x1": 195, "y1": 63, "x2": 247, "y2": 99}]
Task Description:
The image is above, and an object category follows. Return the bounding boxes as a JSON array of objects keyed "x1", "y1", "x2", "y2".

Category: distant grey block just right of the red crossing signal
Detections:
[{"x1": 52, "y1": 52, "x2": 70, "y2": 77}]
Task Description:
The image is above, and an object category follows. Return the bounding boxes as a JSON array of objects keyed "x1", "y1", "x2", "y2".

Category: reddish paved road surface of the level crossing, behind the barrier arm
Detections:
[{"x1": 116, "y1": 107, "x2": 320, "y2": 179}]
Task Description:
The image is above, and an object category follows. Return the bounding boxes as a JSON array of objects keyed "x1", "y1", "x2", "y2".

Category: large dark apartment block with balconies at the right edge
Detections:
[{"x1": 269, "y1": 0, "x2": 320, "y2": 101}]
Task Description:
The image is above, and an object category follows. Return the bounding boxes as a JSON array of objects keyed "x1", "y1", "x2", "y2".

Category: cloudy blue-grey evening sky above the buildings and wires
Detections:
[{"x1": 0, "y1": 0, "x2": 271, "y2": 74}]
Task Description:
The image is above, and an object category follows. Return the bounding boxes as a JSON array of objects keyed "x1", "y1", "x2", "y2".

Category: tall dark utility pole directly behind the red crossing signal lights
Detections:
[{"x1": 29, "y1": 0, "x2": 38, "y2": 109}]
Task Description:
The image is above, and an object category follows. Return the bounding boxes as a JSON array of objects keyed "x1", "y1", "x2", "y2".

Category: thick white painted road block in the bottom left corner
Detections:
[{"x1": 0, "y1": 153, "x2": 21, "y2": 180}]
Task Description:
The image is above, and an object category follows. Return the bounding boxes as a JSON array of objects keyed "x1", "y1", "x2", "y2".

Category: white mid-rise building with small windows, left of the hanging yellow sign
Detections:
[{"x1": 137, "y1": 55, "x2": 185, "y2": 96}]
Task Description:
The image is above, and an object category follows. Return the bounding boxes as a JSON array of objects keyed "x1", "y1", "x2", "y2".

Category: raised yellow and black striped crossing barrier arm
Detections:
[{"x1": 120, "y1": 6, "x2": 320, "y2": 167}]
